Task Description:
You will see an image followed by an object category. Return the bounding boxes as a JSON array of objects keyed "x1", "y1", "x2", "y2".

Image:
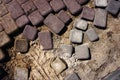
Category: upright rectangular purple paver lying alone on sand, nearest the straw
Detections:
[{"x1": 38, "y1": 31, "x2": 53, "y2": 50}]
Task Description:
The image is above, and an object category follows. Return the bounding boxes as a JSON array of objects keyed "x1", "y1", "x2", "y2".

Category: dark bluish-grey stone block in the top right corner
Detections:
[{"x1": 106, "y1": 0, "x2": 120, "y2": 15}]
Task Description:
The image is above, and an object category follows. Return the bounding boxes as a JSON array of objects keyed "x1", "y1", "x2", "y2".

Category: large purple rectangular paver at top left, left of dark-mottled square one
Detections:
[{"x1": 7, "y1": 0, "x2": 24, "y2": 19}]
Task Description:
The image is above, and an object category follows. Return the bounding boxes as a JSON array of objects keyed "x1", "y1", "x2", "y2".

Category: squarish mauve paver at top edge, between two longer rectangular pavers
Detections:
[{"x1": 50, "y1": 0, "x2": 65, "y2": 12}]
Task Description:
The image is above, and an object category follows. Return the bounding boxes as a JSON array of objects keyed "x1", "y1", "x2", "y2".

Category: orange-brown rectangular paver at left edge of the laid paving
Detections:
[{"x1": 2, "y1": 14, "x2": 18, "y2": 34}]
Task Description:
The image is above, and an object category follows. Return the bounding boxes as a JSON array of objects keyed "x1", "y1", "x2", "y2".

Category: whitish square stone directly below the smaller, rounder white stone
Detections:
[{"x1": 69, "y1": 29, "x2": 83, "y2": 43}]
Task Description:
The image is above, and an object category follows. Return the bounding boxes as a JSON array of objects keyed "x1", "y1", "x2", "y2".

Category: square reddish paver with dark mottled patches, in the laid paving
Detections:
[{"x1": 22, "y1": 0, "x2": 37, "y2": 15}]
